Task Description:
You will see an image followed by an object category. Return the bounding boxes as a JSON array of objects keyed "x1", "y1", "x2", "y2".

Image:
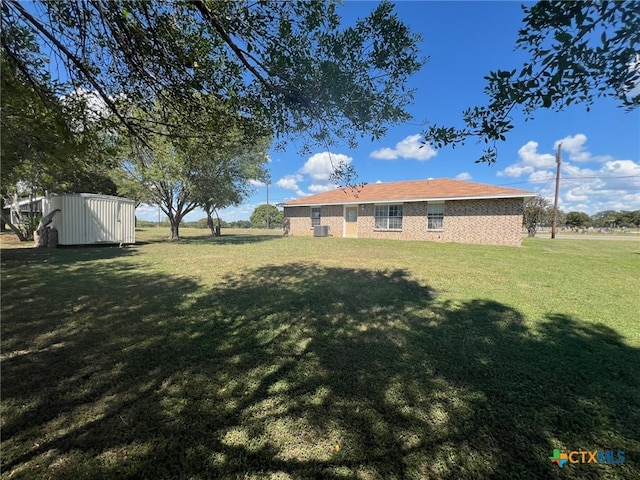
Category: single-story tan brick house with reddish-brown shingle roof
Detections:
[{"x1": 282, "y1": 178, "x2": 536, "y2": 246}]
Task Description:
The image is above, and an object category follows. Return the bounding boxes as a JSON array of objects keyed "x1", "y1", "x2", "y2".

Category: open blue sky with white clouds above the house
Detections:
[{"x1": 138, "y1": 1, "x2": 640, "y2": 221}]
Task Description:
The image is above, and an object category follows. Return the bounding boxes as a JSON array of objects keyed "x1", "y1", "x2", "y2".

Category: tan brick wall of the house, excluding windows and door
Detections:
[{"x1": 285, "y1": 198, "x2": 524, "y2": 246}]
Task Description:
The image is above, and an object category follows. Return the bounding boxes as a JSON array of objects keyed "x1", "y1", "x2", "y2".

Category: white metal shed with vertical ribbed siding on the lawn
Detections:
[{"x1": 43, "y1": 193, "x2": 136, "y2": 245}]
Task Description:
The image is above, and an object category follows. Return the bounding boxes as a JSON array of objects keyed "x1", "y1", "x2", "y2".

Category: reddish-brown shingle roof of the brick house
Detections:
[{"x1": 283, "y1": 178, "x2": 536, "y2": 207}]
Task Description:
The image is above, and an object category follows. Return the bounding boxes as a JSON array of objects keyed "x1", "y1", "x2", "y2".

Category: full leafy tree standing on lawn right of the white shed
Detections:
[{"x1": 120, "y1": 99, "x2": 271, "y2": 240}]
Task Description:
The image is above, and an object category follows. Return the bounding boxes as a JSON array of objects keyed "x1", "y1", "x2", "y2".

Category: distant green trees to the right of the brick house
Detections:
[{"x1": 523, "y1": 197, "x2": 640, "y2": 237}]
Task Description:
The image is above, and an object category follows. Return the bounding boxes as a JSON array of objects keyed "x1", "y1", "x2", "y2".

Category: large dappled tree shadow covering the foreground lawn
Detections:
[{"x1": 2, "y1": 262, "x2": 640, "y2": 479}]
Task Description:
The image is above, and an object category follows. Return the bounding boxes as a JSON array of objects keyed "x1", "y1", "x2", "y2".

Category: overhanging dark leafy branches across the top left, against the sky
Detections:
[{"x1": 2, "y1": 0, "x2": 422, "y2": 150}]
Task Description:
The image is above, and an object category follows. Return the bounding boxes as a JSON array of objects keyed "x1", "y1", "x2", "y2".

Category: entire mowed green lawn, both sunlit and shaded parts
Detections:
[{"x1": 1, "y1": 229, "x2": 640, "y2": 479}]
